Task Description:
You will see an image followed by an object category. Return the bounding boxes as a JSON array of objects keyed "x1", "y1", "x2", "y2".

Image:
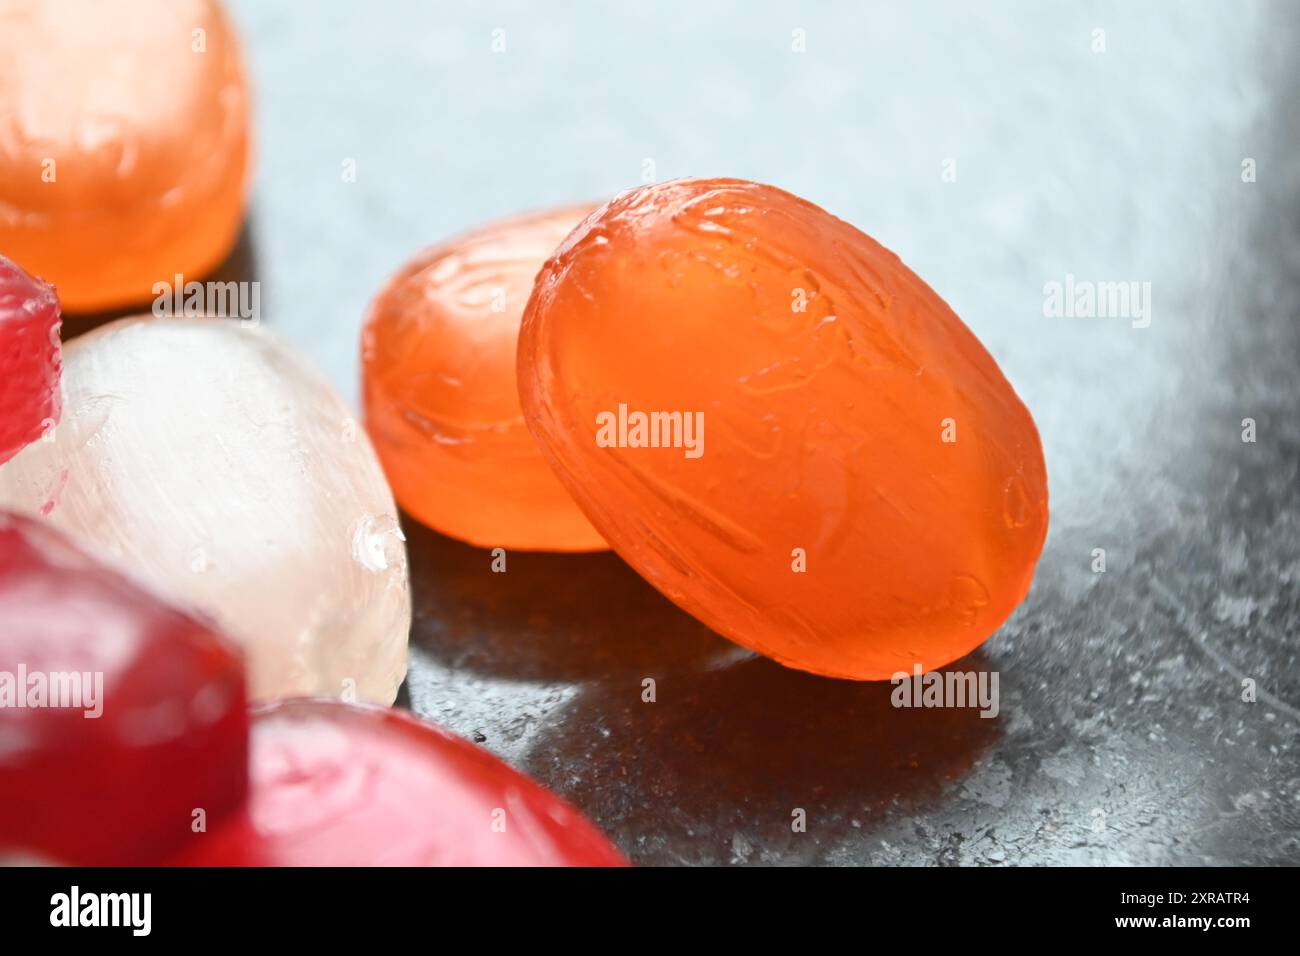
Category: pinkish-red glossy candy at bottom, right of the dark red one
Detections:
[{"x1": 176, "y1": 700, "x2": 624, "y2": 866}]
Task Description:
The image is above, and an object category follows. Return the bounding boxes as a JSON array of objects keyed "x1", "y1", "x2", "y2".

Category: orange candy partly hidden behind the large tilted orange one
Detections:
[{"x1": 361, "y1": 206, "x2": 607, "y2": 551}]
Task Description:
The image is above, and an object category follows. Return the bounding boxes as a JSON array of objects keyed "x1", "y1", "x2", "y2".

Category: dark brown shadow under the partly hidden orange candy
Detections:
[{"x1": 402, "y1": 515, "x2": 750, "y2": 680}]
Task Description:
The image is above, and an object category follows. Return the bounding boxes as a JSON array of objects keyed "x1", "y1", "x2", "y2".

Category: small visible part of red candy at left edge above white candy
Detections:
[{"x1": 0, "y1": 255, "x2": 62, "y2": 464}]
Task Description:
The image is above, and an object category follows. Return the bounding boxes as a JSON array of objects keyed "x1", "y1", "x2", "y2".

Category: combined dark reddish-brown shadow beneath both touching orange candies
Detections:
[{"x1": 403, "y1": 515, "x2": 1001, "y2": 864}]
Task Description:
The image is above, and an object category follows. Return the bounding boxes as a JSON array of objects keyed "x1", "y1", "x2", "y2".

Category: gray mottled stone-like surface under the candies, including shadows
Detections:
[{"x1": 197, "y1": 0, "x2": 1300, "y2": 864}]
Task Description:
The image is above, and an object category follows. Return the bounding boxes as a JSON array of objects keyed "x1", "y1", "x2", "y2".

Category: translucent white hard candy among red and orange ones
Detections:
[{"x1": 0, "y1": 319, "x2": 411, "y2": 702}]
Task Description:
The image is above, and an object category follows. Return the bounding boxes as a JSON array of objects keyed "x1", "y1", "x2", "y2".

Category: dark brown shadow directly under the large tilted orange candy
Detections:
[{"x1": 523, "y1": 652, "x2": 1001, "y2": 865}]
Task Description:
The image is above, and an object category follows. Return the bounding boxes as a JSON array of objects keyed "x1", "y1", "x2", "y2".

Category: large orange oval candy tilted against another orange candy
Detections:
[{"x1": 519, "y1": 179, "x2": 1048, "y2": 679}]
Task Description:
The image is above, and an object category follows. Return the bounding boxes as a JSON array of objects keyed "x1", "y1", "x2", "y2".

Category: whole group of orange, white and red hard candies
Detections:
[{"x1": 0, "y1": 0, "x2": 1048, "y2": 865}]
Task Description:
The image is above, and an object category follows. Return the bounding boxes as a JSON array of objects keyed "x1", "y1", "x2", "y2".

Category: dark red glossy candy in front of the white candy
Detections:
[{"x1": 0, "y1": 512, "x2": 248, "y2": 865}]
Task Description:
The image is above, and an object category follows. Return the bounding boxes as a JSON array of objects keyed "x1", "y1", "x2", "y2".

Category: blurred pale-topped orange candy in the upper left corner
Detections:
[{"x1": 0, "y1": 0, "x2": 248, "y2": 311}]
